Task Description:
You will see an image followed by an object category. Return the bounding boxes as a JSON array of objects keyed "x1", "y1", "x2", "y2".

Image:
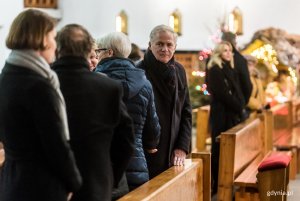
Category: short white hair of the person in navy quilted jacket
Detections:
[{"x1": 97, "y1": 32, "x2": 131, "y2": 58}]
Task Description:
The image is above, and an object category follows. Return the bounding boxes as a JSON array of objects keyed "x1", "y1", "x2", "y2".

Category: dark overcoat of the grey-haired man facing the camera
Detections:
[{"x1": 137, "y1": 50, "x2": 192, "y2": 178}]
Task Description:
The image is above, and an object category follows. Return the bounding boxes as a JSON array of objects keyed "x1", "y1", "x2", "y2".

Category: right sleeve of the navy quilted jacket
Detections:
[{"x1": 143, "y1": 83, "x2": 160, "y2": 149}]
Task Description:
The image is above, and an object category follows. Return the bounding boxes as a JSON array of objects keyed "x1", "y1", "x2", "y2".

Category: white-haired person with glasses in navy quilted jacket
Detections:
[{"x1": 96, "y1": 32, "x2": 160, "y2": 198}]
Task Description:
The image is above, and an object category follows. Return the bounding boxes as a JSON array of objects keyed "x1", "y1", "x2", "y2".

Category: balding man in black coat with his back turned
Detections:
[{"x1": 53, "y1": 24, "x2": 134, "y2": 201}]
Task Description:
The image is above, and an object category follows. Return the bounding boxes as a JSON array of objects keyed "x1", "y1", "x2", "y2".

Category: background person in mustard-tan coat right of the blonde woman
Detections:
[{"x1": 244, "y1": 55, "x2": 266, "y2": 115}]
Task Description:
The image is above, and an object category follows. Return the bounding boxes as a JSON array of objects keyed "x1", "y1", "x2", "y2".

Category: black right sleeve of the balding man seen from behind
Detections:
[{"x1": 111, "y1": 90, "x2": 135, "y2": 186}]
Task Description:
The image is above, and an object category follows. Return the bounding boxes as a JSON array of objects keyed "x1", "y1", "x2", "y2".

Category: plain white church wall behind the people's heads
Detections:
[{"x1": 0, "y1": 0, "x2": 300, "y2": 68}]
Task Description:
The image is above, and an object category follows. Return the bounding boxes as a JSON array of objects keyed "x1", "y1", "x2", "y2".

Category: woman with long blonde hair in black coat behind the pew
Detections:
[{"x1": 207, "y1": 41, "x2": 245, "y2": 194}]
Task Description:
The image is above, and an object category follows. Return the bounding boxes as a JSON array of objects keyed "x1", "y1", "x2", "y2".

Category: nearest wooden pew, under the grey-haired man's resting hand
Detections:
[{"x1": 118, "y1": 153, "x2": 210, "y2": 201}]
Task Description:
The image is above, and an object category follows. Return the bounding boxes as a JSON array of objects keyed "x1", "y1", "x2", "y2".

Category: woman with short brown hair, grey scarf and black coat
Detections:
[{"x1": 0, "y1": 9, "x2": 81, "y2": 201}]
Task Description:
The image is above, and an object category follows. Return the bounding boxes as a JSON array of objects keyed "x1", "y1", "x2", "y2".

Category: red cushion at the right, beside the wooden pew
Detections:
[{"x1": 258, "y1": 153, "x2": 291, "y2": 172}]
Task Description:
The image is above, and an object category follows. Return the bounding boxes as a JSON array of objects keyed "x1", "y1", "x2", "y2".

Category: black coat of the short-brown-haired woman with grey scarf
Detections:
[{"x1": 0, "y1": 63, "x2": 81, "y2": 201}]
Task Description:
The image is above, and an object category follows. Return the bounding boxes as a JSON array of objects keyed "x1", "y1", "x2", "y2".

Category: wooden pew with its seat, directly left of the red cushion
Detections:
[{"x1": 218, "y1": 111, "x2": 291, "y2": 201}]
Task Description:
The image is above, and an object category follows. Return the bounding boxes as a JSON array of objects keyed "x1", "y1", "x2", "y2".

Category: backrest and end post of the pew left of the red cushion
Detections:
[{"x1": 217, "y1": 118, "x2": 264, "y2": 201}]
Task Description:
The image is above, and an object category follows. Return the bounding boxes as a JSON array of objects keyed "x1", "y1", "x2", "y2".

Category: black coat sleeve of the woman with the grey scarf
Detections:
[{"x1": 29, "y1": 83, "x2": 82, "y2": 192}]
